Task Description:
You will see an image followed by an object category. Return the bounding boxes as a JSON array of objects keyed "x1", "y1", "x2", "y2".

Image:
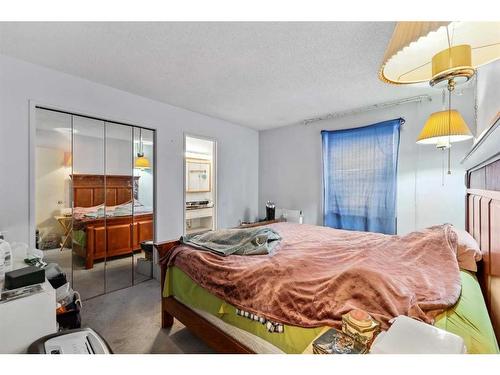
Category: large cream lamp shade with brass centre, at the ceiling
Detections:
[{"x1": 379, "y1": 22, "x2": 500, "y2": 85}]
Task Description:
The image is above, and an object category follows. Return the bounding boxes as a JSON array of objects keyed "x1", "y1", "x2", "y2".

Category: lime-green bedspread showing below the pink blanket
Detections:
[{"x1": 163, "y1": 267, "x2": 499, "y2": 353}]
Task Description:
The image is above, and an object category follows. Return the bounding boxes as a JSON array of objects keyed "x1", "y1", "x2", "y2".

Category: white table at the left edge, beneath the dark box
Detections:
[{"x1": 0, "y1": 261, "x2": 57, "y2": 353}]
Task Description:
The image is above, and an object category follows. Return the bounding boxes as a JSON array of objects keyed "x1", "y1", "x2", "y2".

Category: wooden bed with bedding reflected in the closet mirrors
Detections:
[{"x1": 72, "y1": 174, "x2": 153, "y2": 269}]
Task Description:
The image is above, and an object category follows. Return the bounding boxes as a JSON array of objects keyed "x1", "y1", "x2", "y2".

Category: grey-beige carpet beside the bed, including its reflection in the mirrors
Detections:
[{"x1": 44, "y1": 249, "x2": 213, "y2": 354}]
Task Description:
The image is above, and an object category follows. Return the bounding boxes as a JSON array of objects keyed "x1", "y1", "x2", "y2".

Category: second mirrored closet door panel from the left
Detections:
[{"x1": 70, "y1": 116, "x2": 106, "y2": 299}]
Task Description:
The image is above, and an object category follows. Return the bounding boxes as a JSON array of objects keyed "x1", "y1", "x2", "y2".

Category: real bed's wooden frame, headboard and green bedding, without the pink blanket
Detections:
[{"x1": 157, "y1": 161, "x2": 500, "y2": 353}]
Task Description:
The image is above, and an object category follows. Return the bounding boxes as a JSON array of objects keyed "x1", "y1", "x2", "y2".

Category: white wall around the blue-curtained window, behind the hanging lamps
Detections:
[{"x1": 259, "y1": 89, "x2": 475, "y2": 234}]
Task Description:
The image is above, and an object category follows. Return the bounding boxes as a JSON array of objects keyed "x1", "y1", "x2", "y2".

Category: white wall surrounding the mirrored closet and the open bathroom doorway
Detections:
[{"x1": 0, "y1": 56, "x2": 259, "y2": 242}]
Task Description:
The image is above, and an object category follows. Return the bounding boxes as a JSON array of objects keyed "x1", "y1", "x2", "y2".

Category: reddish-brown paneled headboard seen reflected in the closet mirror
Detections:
[{"x1": 71, "y1": 174, "x2": 139, "y2": 207}]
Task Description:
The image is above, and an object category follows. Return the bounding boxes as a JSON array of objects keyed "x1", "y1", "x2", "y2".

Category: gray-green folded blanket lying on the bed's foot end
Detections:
[{"x1": 180, "y1": 227, "x2": 281, "y2": 256}]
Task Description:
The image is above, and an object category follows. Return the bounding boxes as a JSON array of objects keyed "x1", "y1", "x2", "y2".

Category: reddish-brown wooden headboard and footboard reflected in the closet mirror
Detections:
[{"x1": 71, "y1": 174, "x2": 153, "y2": 269}]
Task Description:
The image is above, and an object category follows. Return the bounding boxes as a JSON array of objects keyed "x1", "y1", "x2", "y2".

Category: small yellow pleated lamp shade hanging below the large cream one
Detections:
[{"x1": 417, "y1": 109, "x2": 472, "y2": 147}]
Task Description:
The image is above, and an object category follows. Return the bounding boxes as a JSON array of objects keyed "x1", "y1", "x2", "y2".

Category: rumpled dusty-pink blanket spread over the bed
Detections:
[{"x1": 167, "y1": 223, "x2": 461, "y2": 329}]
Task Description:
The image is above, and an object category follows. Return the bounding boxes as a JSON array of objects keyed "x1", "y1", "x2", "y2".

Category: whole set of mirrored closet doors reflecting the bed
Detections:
[{"x1": 35, "y1": 108, "x2": 155, "y2": 299}]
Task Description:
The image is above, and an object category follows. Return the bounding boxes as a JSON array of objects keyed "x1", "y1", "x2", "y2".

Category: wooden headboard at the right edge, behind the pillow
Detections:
[{"x1": 466, "y1": 160, "x2": 500, "y2": 341}]
